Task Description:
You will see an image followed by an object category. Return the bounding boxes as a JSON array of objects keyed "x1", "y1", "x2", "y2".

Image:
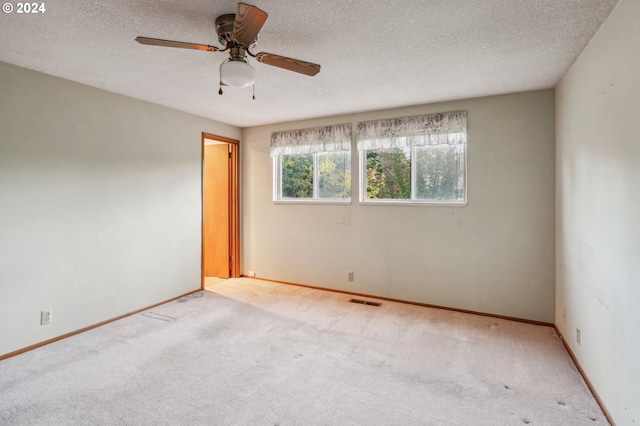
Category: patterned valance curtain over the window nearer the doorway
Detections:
[{"x1": 271, "y1": 124, "x2": 351, "y2": 157}]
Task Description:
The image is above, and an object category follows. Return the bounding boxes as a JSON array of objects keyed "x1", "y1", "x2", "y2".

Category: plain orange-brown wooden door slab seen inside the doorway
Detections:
[{"x1": 202, "y1": 142, "x2": 231, "y2": 278}]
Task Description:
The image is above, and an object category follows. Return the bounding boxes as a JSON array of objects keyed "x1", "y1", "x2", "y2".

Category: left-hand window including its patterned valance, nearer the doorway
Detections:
[{"x1": 271, "y1": 124, "x2": 351, "y2": 202}]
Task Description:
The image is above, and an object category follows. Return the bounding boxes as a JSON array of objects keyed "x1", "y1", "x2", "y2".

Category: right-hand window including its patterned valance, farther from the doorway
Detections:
[{"x1": 357, "y1": 111, "x2": 467, "y2": 204}]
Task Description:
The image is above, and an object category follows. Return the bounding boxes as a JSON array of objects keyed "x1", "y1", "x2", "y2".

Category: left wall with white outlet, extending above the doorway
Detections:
[{"x1": 0, "y1": 63, "x2": 240, "y2": 355}]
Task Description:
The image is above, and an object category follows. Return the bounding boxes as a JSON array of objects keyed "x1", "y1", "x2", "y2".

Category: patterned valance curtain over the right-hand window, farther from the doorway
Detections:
[{"x1": 357, "y1": 111, "x2": 467, "y2": 150}]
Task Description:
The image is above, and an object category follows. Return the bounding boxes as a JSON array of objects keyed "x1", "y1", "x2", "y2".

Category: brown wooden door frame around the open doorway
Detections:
[{"x1": 200, "y1": 132, "x2": 240, "y2": 290}]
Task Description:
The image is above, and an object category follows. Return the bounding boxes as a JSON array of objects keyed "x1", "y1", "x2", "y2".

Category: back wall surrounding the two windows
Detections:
[{"x1": 242, "y1": 90, "x2": 555, "y2": 323}]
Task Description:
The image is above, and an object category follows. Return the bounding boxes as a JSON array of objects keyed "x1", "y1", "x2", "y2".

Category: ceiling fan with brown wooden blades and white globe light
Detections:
[{"x1": 136, "y1": 3, "x2": 320, "y2": 99}]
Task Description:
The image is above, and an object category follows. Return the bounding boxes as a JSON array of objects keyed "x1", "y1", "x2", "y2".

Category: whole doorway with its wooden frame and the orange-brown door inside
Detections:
[{"x1": 201, "y1": 133, "x2": 240, "y2": 289}]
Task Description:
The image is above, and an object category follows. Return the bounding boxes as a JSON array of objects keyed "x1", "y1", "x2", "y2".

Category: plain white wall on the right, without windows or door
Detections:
[{"x1": 556, "y1": 0, "x2": 640, "y2": 425}]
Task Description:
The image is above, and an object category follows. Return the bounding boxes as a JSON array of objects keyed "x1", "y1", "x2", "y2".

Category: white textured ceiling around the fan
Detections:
[{"x1": 0, "y1": 0, "x2": 617, "y2": 127}]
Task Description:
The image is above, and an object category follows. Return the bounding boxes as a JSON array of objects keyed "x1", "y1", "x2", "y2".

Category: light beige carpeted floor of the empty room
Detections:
[{"x1": 0, "y1": 279, "x2": 607, "y2": 426}]
